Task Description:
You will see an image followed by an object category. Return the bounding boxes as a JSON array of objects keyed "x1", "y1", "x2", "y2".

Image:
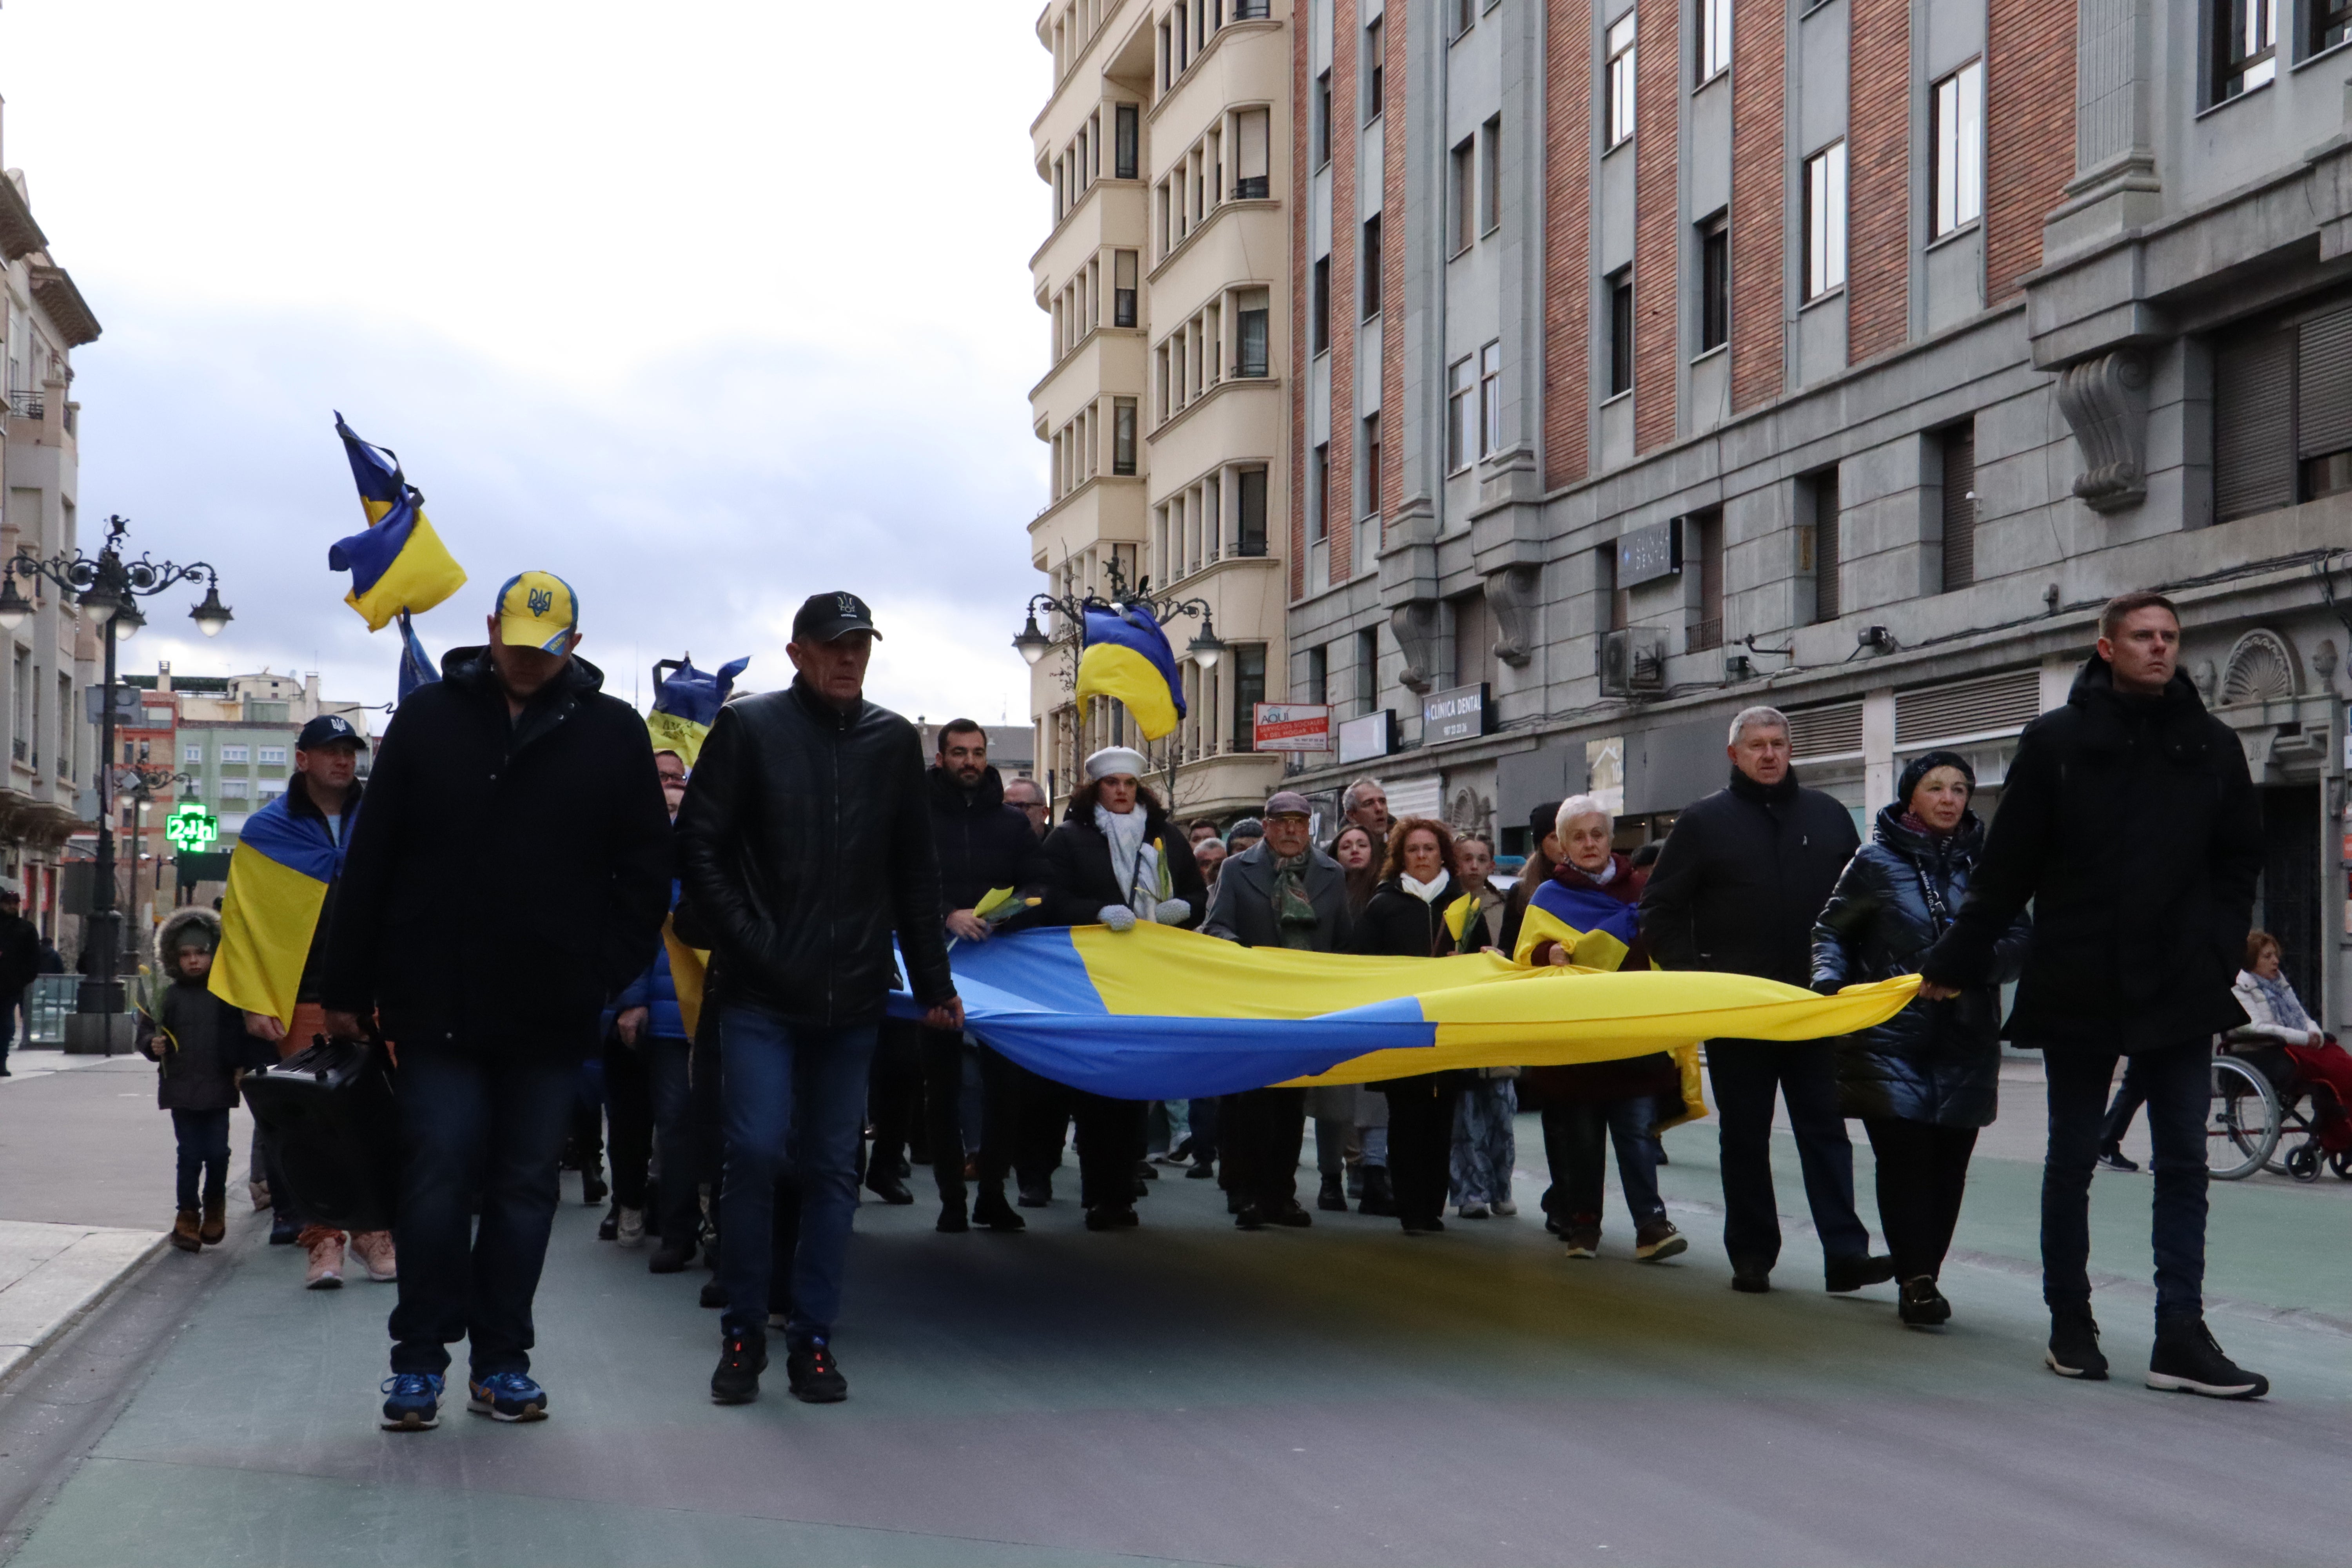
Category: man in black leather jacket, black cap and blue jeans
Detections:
[{"x1": 677, "y1": 592, "x2": 964, "y2": 1403}]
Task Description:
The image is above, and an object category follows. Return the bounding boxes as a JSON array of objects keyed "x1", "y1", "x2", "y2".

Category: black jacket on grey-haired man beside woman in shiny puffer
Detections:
[{"x1": 1642, "y1": 769, "x2": 1860, "y2": 985}]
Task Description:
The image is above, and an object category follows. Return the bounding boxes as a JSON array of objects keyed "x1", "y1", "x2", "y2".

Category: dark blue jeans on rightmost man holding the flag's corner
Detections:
[{"x1": 2042, "y1": 1039, "x2": 2213, "y2": 1321}]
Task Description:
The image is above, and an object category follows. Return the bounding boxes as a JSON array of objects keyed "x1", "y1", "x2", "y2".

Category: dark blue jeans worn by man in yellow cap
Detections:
[{"x1": 393, "y1": 1046, "x2": 579, "y2": 1377}]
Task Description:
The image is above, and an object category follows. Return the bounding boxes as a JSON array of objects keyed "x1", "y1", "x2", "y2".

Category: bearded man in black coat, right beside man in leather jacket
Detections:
[{"x1": 908, "y1": 719, "x2": 1044, "y2": 1232}]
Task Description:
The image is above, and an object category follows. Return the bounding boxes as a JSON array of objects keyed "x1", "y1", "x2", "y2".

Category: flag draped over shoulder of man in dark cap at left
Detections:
[{"x1": 209, "y1": 795, "x2": 360, "y2": 1027}]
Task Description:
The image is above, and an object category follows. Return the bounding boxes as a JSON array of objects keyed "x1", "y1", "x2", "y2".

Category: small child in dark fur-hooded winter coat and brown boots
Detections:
[{"x1": 139, "y1": 910, "x2": 275, "y2": 1253}]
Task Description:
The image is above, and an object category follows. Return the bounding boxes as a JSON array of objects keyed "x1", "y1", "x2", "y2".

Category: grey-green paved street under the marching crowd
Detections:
[{"x1": 0, "y1": 1063, "x2": 2352, "y2": 1568}]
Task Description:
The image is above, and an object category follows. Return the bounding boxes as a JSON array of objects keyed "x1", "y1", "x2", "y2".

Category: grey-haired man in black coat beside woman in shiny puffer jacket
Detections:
[{"x1": 1642, "y1": 708, "x2": 1893, "y2": 1290}]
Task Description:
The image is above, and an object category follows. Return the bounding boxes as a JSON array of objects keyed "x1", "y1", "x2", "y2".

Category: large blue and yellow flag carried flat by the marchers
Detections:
[{"x1": 891, "y1": 924, "x2": 1919, "y2": 1100}]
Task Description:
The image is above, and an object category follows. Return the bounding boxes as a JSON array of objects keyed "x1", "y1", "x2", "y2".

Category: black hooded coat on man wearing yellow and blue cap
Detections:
[{"x1": 320, "y1": 649, "x2": 670, "y2": 1056}]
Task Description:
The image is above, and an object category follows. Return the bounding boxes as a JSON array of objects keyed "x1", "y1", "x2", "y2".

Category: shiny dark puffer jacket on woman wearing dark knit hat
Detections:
[{"x1": 1813, "y1": 804, "x2": 2032, "y2": 1126}]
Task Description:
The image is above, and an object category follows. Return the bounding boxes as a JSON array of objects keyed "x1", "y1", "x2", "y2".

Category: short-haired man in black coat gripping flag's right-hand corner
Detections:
[{"x1": 1919, "y1": 592, "x2": 2270, "y2": 1399}]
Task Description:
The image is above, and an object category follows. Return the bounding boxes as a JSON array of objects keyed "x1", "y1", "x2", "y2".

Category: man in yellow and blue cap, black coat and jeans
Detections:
[{"x1": 320, "y1": 571, "x2": 670, "y2": 1432}]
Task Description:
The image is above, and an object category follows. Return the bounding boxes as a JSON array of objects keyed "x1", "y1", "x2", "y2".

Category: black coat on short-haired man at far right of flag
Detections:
[{"x1": 1919, "y1": 656, "x2": 2263, "y2": 1053}]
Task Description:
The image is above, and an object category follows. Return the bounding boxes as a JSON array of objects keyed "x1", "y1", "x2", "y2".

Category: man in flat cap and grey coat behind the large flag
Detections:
[{"x1": 1200, "y1": 790, "x2": 1350, "y2": 1229}]
